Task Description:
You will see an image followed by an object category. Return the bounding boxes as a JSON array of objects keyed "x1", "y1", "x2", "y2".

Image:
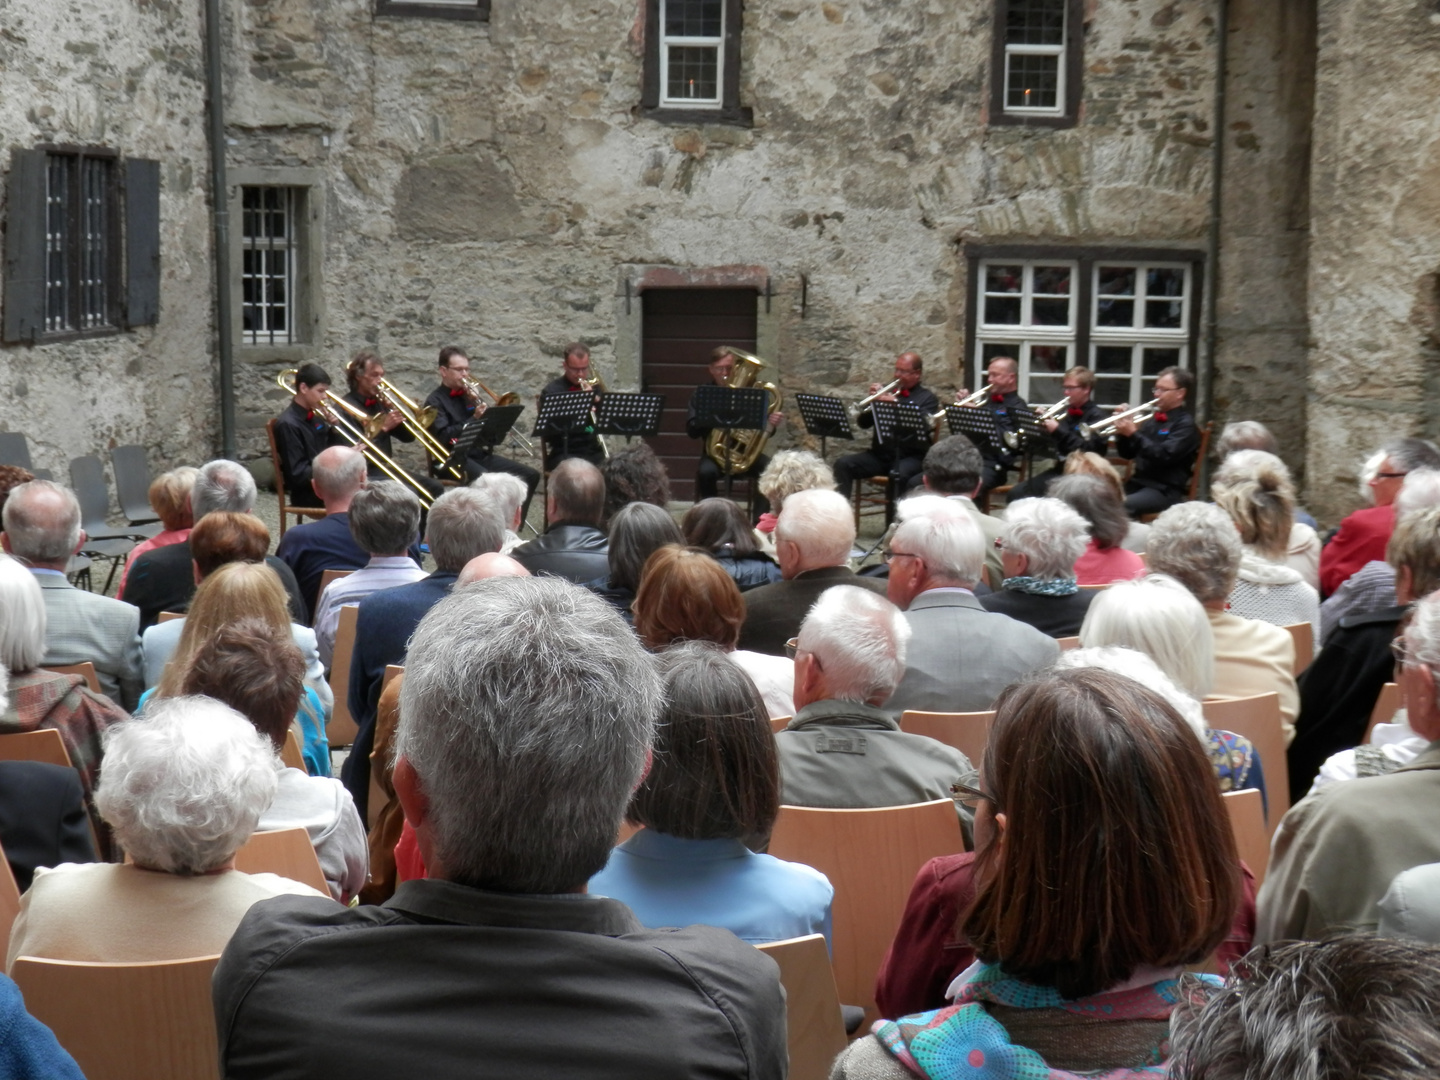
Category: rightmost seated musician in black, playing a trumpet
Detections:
[{"x1": 1115, "y1": 367, "x2": 1200, "y2": 517}]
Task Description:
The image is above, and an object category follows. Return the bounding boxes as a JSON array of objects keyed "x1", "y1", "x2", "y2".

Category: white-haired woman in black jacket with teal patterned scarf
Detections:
[{"x1": 981, "y1": 498, "x2": 1094, "y2": 638}]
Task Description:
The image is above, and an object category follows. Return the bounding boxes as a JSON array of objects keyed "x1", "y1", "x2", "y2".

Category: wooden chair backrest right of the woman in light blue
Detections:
[{"x1": 770, "y1": 799, "x2": 965, "y2": 1020}]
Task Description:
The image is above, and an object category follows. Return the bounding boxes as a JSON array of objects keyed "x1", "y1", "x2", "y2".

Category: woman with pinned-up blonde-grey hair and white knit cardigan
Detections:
[{"x1": 1211, "y1": 451, "x2": 1320, "y2": 624}]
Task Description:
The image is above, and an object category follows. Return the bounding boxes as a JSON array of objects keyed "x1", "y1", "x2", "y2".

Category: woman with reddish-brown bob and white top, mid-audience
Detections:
[{"x1": 635, "y1": 544, "x2": 795, "y2": 719}]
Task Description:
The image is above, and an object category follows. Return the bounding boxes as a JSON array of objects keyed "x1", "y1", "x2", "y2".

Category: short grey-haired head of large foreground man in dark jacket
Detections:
[{"x1": 396, "y1": 577, "x2": 664, "y2": 894}]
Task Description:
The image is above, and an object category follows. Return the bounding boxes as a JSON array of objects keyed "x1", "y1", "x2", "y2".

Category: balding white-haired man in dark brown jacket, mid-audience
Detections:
[{"x1": 740, "y1": 490, "x2": 886, "y2": 657}]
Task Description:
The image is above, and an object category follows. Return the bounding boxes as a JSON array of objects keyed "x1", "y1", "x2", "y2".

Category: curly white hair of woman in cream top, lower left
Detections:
[{"x1": 95, "y1": 697, "x2": 276, "y2": 874}]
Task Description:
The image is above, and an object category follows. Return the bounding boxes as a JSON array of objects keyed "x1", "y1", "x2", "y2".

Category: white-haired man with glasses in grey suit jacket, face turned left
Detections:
[{"x1": 875, "y1": 495, "x2": 1060, "y2": 720}]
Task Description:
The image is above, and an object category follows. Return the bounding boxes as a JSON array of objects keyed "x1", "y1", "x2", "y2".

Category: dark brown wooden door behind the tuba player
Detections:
[{"x1": 641, "y1": 288, "x2": 773, "y2": 503}]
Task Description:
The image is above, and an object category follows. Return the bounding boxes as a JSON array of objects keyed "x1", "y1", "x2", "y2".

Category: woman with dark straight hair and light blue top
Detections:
[{"x1": 589, "y1": 642, "x2": 835, "y2": 945}]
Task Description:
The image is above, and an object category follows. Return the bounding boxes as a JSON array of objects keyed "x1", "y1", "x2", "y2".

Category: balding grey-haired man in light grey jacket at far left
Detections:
[{"x1": 0, "y1": 480, "x2": 143, "y2": 710}]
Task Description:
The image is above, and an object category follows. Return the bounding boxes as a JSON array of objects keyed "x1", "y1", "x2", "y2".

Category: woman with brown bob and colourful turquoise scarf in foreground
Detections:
[{"x1": 831, "y1": 668, "x2": 1241, "y2": 1080}]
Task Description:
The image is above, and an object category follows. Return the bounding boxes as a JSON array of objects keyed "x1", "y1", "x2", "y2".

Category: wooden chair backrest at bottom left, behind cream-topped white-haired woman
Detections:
[{"x1": 10, "y1": 956, "x2": 220, "y2": 1080}]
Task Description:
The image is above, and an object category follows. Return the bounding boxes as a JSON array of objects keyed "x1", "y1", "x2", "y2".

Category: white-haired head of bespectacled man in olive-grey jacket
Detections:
[{"x1": 798, "y1": 585, "x2": 910, "y2": 704}]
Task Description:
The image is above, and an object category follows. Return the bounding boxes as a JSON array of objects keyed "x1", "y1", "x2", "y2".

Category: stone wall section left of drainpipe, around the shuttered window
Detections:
[{"x1": 0, "y1": 0, "x2": 219, "y2": 480}]
